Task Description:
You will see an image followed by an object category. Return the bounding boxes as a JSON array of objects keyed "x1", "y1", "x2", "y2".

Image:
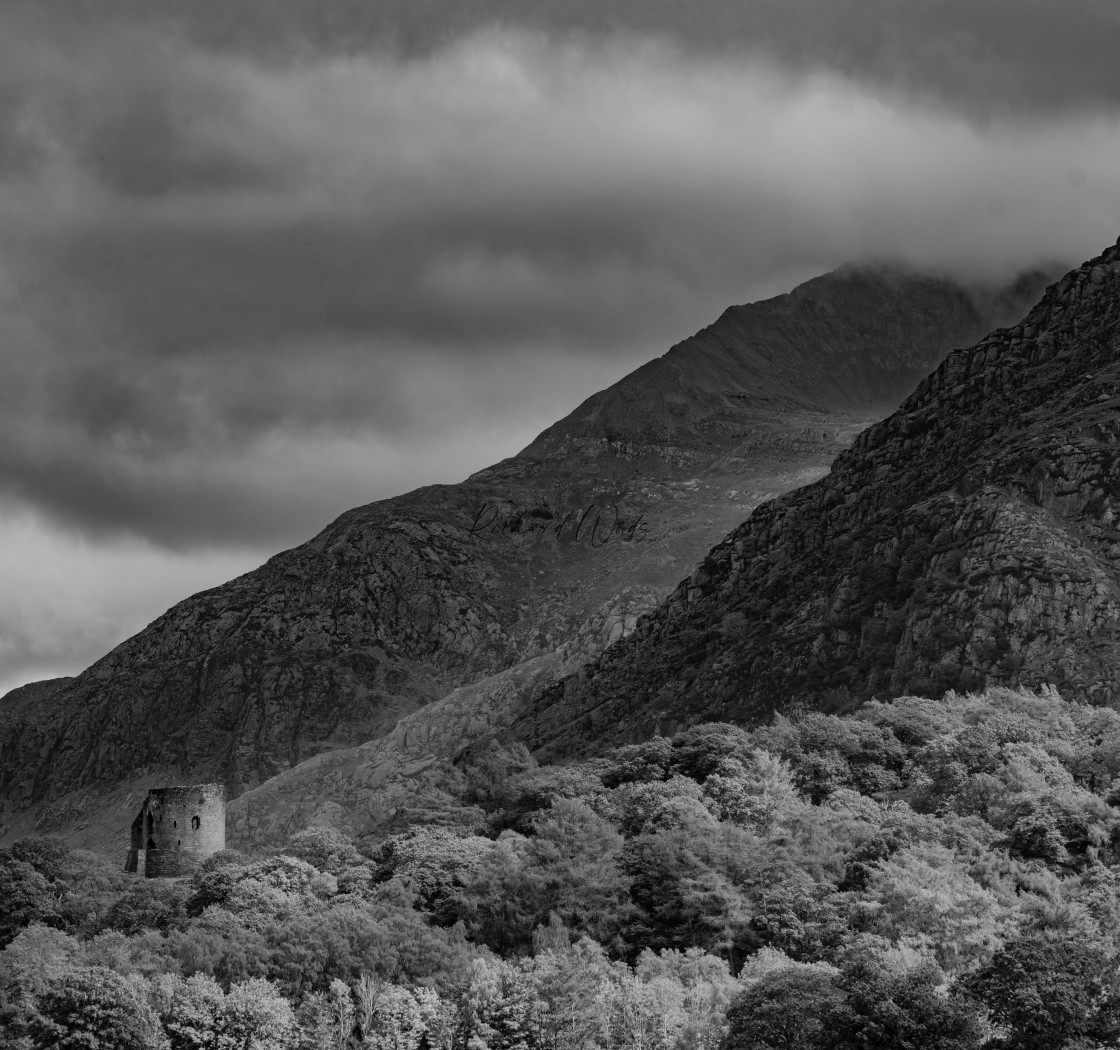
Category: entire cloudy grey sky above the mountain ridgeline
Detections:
[{"x1": 0, "y1": 0, "x2": 1120, "y2": 692}]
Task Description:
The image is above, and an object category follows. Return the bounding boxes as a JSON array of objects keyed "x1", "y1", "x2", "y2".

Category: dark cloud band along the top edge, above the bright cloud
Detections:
[{"x1": 15, "y1": 0, "x2": 1120, "y2": 116}]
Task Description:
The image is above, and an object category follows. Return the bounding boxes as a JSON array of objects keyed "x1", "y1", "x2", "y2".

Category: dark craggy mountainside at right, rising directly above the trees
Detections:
[{"x1": 511, "y1": 241, "x2": 1120, "y2": 754}]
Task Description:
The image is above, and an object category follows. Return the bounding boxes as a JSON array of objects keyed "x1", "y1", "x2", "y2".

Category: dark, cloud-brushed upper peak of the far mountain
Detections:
[{"x1": 519, "y1": 266, "x2": 1057, "y2": 469}]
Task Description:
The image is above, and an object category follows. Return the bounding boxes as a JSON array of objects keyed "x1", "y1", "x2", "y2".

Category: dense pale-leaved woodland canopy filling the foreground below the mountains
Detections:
[{"x1": 0, "y1": 690, "x2": 1120, "y2": 1050}]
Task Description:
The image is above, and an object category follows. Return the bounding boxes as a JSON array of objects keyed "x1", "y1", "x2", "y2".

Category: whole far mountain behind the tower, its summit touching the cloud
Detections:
[{"x1": 0, "y1": 261, "x2": 1043, "y2": 833}]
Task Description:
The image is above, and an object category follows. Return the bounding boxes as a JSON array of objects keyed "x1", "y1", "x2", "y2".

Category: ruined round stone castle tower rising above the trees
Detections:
[{"x1": 124, "y1": 784, "x2": 225, "y2": 879}]
